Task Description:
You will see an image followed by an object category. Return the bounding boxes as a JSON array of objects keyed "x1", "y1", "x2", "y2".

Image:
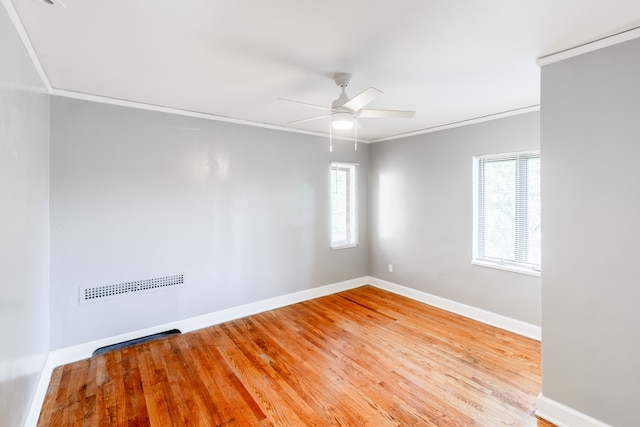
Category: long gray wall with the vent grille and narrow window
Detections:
[{"x1": 51, "y1": 96, "x2": 369, "y2": 349}]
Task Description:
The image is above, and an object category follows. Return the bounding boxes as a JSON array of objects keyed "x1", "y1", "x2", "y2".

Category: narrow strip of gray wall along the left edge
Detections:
[{"x1": 0, "y1": 6, "x2": 49, "y2": 426}]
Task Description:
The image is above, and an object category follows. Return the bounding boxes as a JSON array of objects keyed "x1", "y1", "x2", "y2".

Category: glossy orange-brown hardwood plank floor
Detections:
[{"x1": 38, "y1": 286, "x2": 553, "y2": 427}]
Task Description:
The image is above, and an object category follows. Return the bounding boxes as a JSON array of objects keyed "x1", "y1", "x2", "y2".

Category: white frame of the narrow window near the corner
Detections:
[{"x1": 329, "y1": 162, "x2": 358, "y2": 250}]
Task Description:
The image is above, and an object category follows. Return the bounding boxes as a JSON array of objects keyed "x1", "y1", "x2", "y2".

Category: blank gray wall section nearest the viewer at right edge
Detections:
[{"x1": 541, "y1": 40, "x2": 640, "y2": 426}]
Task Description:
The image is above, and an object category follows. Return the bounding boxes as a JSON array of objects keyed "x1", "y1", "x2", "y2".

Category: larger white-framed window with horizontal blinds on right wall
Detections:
[{"x1": 473, "y1": 151, "x2": 542, "y2": 275}]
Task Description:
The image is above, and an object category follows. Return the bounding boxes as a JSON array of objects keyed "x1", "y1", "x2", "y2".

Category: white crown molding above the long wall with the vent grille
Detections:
[{"x1": 50, "y1": 89, "x2": 360, "y2": 143}]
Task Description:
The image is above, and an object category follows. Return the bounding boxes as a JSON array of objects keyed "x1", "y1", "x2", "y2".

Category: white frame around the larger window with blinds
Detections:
[{"x1": 471, "y1": 150, "x2": 541, "y2": 277}]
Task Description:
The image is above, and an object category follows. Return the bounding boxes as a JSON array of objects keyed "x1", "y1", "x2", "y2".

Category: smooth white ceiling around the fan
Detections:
[{"x1": 7, "y1": 0, "x2": 640, "y2": 140}]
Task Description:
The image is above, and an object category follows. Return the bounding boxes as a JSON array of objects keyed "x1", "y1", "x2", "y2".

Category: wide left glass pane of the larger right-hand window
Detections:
[{"x1": 484, "y1": 159, "x2": 516, "y2": 261}]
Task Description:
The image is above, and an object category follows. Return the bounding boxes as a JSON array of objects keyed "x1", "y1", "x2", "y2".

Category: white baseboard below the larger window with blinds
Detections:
[{"x1": 369, "y1": 277, "x2": 541, "y2": 341}]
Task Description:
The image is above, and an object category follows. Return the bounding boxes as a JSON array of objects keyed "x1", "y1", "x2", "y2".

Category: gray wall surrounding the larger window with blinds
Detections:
[{"x1": 369, "y1": 112, "x2": 544, "y2": 325}]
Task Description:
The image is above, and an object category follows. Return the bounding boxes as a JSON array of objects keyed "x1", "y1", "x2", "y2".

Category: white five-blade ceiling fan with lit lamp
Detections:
[{"x1": 281, "y1": 73, "x2": 416, "y2": 129}]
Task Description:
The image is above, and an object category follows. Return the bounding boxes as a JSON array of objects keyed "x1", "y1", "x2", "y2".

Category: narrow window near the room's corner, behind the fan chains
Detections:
[{"x1": 330, "y1": 163, "x2": 358, "y2": 249}]
